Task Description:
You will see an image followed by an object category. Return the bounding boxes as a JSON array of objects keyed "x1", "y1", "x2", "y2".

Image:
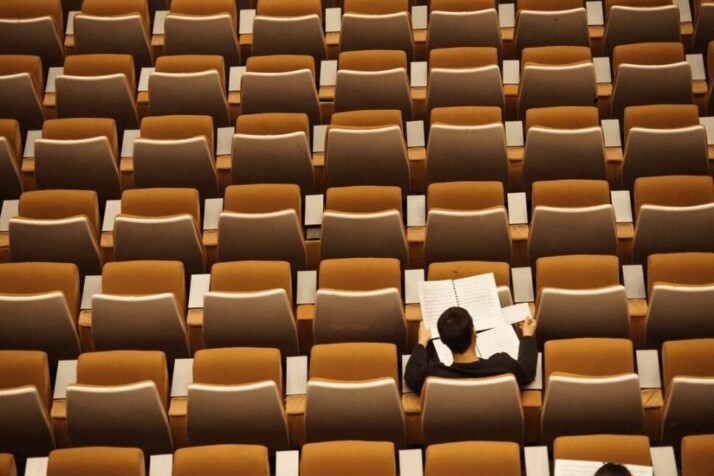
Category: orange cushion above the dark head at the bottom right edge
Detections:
[{"x1": 553, "y1": 435, "x2": 652, "y2": 466}]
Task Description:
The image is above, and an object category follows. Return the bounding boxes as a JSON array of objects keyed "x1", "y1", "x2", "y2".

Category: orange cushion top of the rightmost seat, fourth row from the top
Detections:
[{"x1": 634, "y1": 175, "x2": 714, "y2": 217}]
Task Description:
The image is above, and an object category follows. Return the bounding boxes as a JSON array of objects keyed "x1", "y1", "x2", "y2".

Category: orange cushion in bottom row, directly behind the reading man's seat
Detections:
[{"x1": 425, "y1": 441, "x2": 521, "y2": 476}]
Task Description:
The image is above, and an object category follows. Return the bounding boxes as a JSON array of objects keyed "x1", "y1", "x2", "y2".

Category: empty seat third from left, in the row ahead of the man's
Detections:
[{"x1": 203, "y1": 261, "x2": 298, "y2": 358}]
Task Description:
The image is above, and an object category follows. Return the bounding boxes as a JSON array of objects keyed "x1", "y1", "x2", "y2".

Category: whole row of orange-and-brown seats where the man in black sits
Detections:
[{"x1": 0, "y1": 338, "x2": 714, "y2": 458}]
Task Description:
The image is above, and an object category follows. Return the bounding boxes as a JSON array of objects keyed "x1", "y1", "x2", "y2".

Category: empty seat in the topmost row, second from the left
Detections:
[{"x1": 74, "y1": 0, "x2": 154, "y2": 68}]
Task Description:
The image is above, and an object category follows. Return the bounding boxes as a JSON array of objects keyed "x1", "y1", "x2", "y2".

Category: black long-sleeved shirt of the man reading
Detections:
[{"x1": 404, "y1": 336, "x2": 538, "y2": 392}]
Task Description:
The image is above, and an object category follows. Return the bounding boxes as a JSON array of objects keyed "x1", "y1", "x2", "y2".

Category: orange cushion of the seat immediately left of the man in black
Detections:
[{"x1": 310, "y1": 342, "x2": 398, "y2": 383}]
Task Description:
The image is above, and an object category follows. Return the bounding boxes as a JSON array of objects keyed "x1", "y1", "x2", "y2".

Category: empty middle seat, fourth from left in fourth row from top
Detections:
[{"x1": 320, "y1": 186, "x2": 407, "y2": 268}]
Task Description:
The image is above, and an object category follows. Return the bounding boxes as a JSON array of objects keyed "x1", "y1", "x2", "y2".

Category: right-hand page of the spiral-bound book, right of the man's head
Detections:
[{"x1": 454, "y1": 273, "x2": 503, "y2": 331}]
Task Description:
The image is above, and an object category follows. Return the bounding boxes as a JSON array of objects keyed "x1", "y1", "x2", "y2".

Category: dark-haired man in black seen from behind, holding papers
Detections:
[{"x1": 404, "y1": 307, "x2": 538, "y2": 392}]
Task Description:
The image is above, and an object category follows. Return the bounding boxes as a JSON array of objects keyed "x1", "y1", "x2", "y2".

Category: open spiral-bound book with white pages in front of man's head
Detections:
[{"x1": 417, "y1": 273, "x2": 531, "y2": 337}]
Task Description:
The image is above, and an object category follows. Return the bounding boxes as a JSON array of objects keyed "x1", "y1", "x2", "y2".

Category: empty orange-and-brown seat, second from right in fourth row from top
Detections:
[{"x1": 528, "y1": 180, "x2": 617, "y2": 266}]
